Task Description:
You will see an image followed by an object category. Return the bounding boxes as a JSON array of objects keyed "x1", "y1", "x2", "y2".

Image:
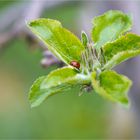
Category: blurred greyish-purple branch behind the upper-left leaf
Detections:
[{"x1": 0, "y1": 0, "x2": 66, "y2": 67}]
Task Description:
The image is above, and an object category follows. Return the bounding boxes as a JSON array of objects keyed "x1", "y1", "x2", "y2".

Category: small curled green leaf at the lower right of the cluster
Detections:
[{"x1": 91, "y1": 70, "x2": 131, "y2": 107}]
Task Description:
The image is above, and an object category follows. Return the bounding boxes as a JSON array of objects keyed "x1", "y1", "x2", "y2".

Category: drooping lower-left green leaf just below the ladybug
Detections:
[{"x1": 29, "y1": 67, "x2": 90, "y2": 107}]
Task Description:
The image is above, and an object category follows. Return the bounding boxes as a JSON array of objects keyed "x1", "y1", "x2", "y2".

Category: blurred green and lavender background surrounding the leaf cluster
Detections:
[{"x1": 0, "y1": 0, "x2": 140, "y2": 139}]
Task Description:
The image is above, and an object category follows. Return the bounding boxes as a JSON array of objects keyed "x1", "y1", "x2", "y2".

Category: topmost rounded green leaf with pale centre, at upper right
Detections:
[{"x1": 92, "y1": 10, "x2": 132, "y2": 48}]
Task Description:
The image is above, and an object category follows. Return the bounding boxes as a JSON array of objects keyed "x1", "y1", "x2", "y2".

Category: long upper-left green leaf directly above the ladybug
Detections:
[{"x1": 27, "y1": 19, "x2": 84, "y2": 64}]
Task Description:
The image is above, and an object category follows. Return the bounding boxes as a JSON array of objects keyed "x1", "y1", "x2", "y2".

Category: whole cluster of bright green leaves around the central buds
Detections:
[{"x1": 28, "y1": 11, "x2": 140, "y2": 107}]
